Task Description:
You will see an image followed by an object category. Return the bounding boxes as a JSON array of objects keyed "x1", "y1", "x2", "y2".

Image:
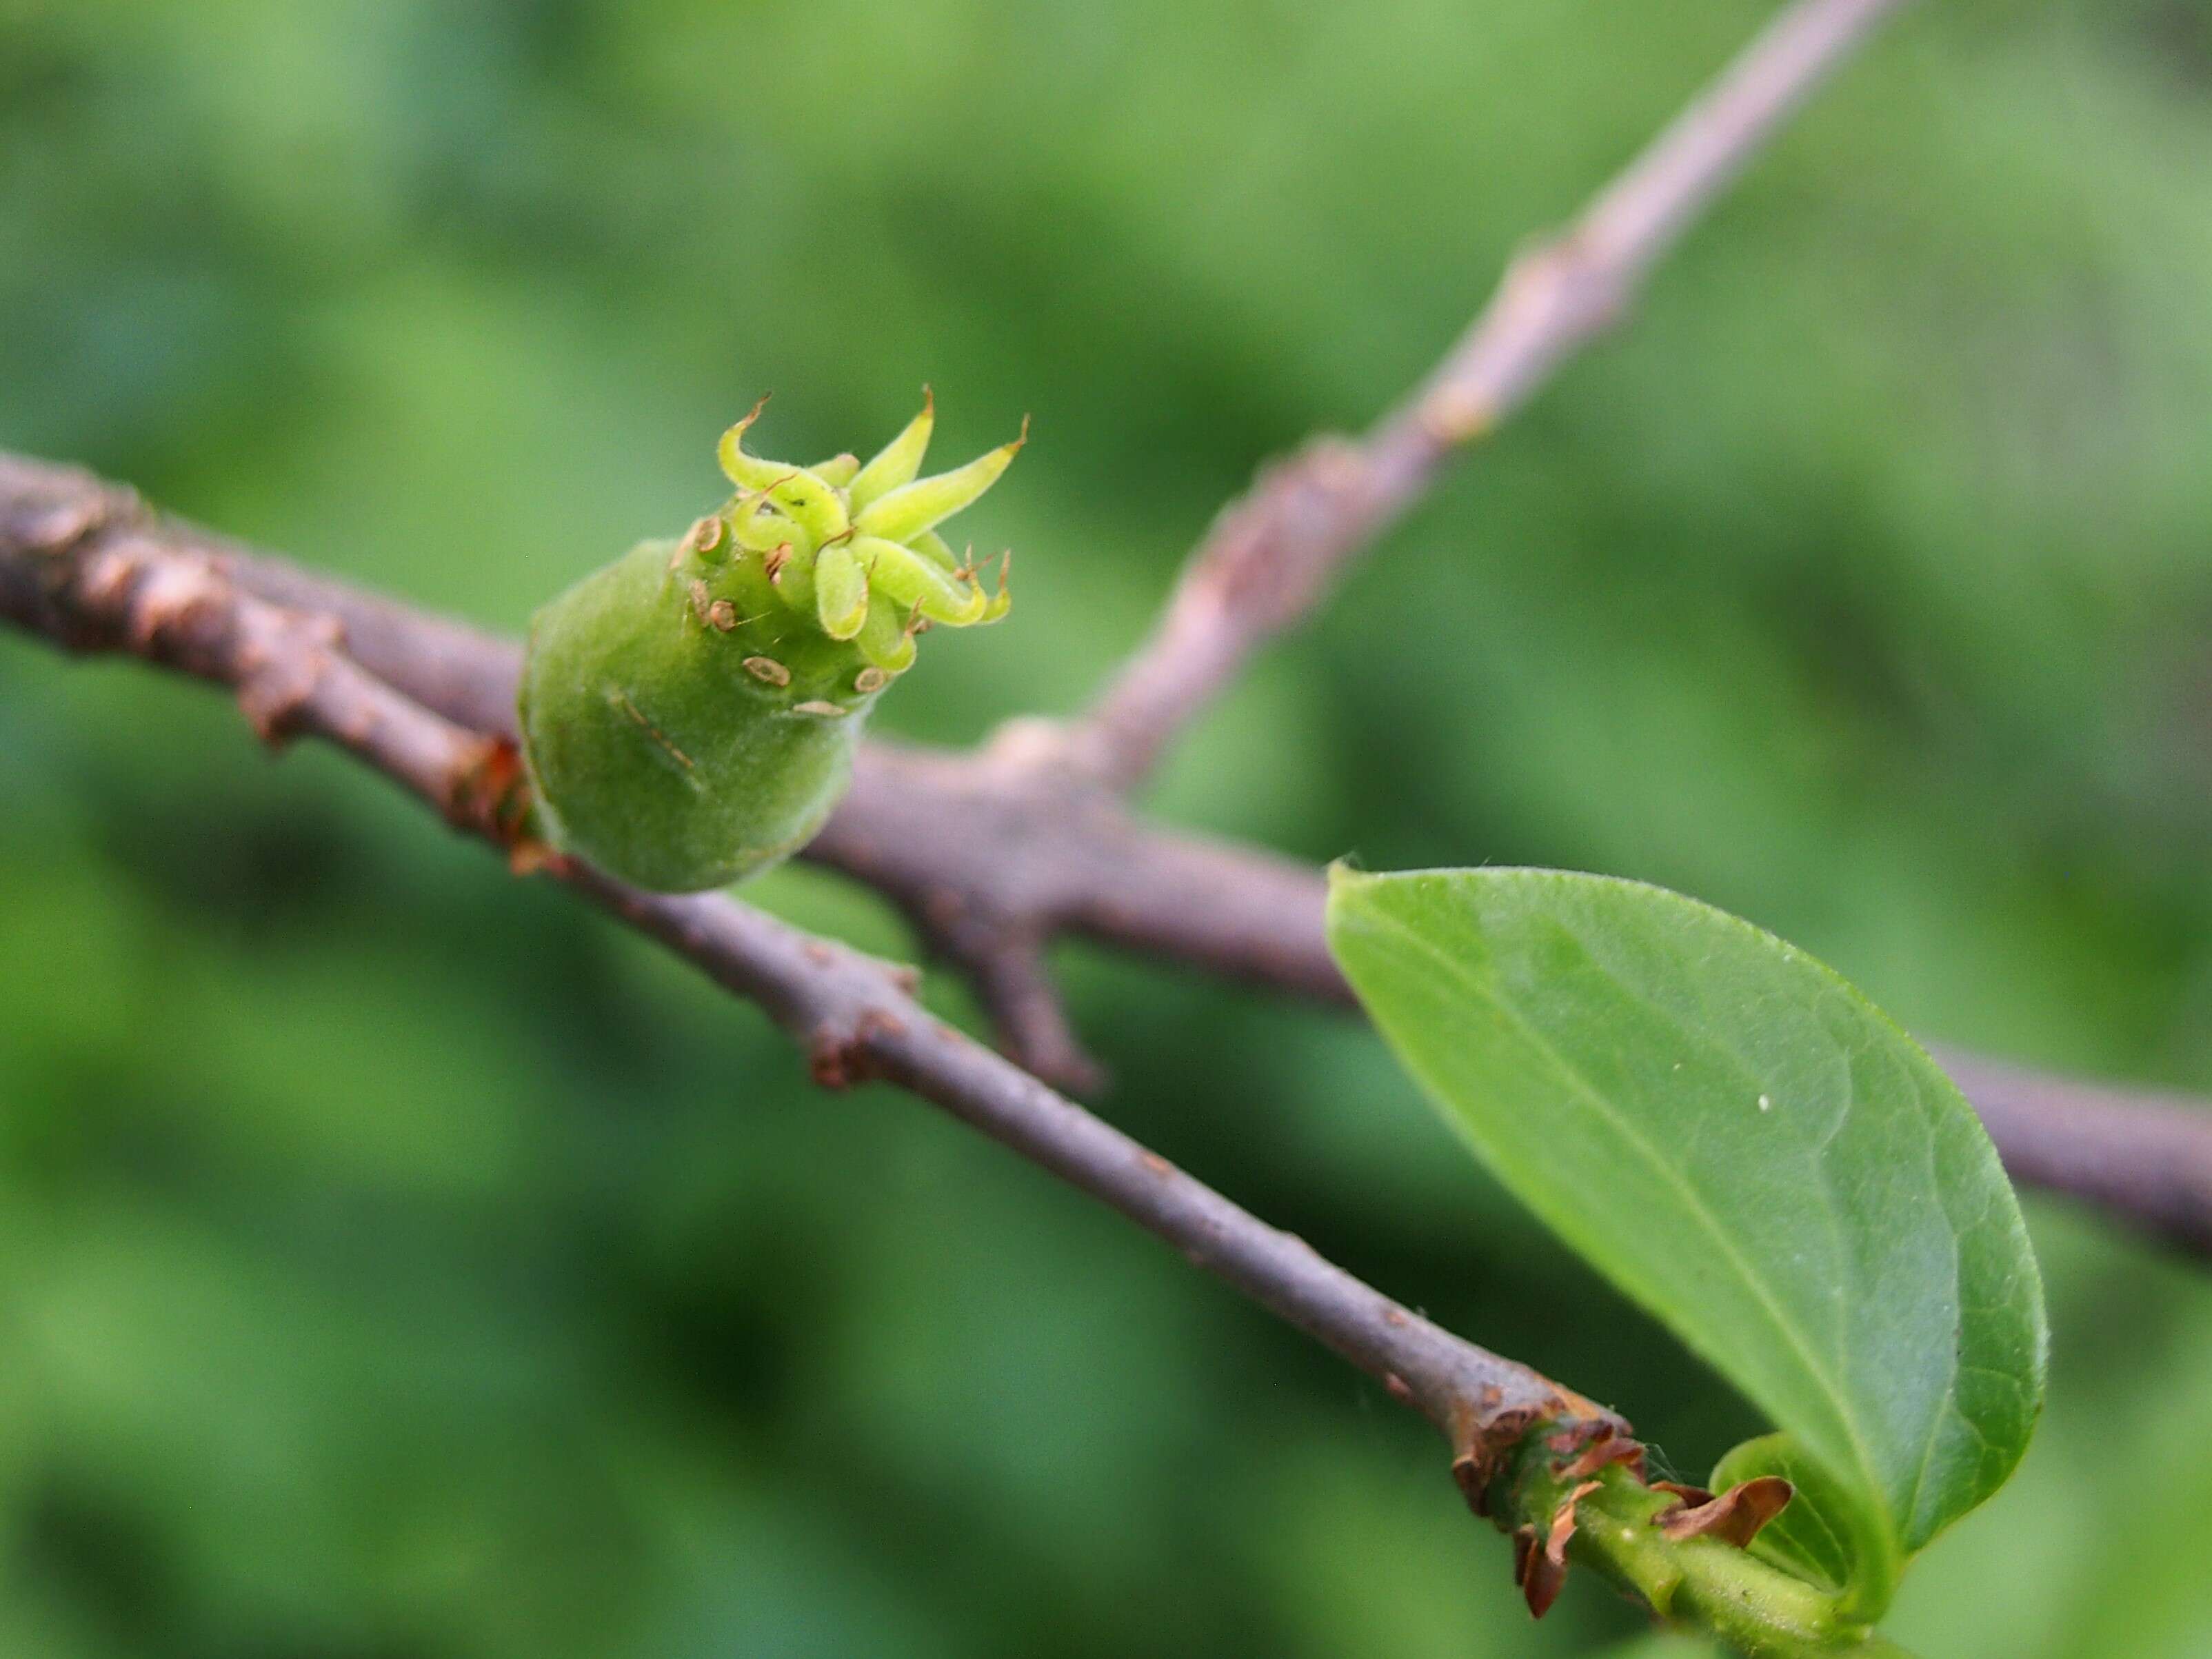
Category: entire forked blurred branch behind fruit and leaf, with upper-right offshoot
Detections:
[{"x1": 17, "y1": 0, "x2": 2212, "y2": 1254}]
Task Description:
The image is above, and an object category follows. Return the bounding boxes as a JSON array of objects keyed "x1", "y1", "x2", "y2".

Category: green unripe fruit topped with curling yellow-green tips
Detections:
[{"x1": 518, "y1": 401, "x2": 1027, "y2": 894}]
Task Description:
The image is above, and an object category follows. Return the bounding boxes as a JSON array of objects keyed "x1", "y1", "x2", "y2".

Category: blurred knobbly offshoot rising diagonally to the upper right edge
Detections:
[{"x1": 1066, "y1": 0, "x2": 1904, "y2": 790}]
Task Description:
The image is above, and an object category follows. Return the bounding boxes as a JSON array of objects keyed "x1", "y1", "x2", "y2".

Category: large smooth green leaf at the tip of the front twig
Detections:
[{"x1": 1329, "y1": 867, "x2": 2046, "y2": 1617}]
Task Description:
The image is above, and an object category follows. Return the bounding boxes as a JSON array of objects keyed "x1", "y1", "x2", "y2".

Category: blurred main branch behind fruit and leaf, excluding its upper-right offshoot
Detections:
[{"x1": 17, "y1": 454, "x2": 2212, "y2": 1256}]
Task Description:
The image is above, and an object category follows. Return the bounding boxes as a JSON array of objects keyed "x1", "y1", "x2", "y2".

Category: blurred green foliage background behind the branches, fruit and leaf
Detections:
[{"x1": 0, "y1": 0, "x2": 2212, "y2": 1659}]
